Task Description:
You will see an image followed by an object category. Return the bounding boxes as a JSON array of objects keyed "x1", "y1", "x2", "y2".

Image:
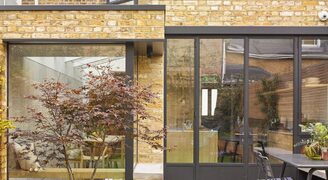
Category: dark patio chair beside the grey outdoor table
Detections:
[{"x1": 254, "y1": 152, "x2": 293, "y2": 180}]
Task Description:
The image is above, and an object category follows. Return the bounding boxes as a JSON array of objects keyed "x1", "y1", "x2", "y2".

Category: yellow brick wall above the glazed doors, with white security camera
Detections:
[{"x1": 139, "y1": 0, "x2": 328, "y2": 26}]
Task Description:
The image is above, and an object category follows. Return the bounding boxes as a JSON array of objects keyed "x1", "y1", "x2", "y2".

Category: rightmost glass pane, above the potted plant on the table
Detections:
[{"x1": 302, "y1": 38, "x2": 328, "y2": 124}]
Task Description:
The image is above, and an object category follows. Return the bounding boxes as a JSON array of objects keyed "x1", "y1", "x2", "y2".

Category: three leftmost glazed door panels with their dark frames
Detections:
[{"x1": 164, "y1": 36, "x2": 302, "y2": 180}]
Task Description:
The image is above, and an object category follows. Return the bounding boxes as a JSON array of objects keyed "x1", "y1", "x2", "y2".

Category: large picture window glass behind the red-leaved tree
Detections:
[{"x1": 8, "y1": 44, "x2": 126, "y2": 179}]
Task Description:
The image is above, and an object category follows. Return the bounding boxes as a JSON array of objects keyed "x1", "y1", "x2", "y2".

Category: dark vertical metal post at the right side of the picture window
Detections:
[{"x1": 125, "y1": 43, "x2": 134, "y2": 180}]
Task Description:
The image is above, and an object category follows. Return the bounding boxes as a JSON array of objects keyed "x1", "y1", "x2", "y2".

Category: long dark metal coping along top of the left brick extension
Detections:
[{"x1": 0, "y1": 4, "x2": 165, "y2": 11}]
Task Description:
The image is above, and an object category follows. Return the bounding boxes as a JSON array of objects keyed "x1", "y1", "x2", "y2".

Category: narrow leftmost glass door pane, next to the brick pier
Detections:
[{"x1": 166, "y1": 39, "x2": 194, "y2": 163}]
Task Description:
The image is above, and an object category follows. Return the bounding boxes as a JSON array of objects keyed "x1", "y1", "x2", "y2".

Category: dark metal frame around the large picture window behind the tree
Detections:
[{"x1": 4, "y1": 40, "x2": 134, "y2": 180}]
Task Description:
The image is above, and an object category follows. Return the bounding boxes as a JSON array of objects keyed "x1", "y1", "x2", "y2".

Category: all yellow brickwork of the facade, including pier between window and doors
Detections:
[{"x1": 0, "y1": 0, "x2": 328, "y2": 179}]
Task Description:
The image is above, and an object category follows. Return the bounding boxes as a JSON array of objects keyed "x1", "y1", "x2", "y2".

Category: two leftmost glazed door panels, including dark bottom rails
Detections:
[{"x1": 164, "y1": 38, "x2": 245, "y2": 180}]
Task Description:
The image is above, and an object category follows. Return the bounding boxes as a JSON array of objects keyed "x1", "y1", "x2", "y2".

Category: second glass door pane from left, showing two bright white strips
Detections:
[{"x1": 199, "y1": 39, "x2": 244, "y2": 163}]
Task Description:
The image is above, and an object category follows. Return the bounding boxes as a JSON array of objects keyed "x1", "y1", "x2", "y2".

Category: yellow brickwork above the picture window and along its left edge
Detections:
[{"x1": 0, "y1": 11, "x2": 164, "y2": 179}]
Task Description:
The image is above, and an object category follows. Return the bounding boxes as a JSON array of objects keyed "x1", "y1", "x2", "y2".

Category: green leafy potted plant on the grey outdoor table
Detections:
[{"x1": 298, "y1": 123, "x2": 328, "y2": 160}]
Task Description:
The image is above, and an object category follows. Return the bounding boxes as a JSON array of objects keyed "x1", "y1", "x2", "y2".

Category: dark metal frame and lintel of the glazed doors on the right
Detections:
[{"x1": 164, "y1": 27, "x2": 328, "y2": 180}]
